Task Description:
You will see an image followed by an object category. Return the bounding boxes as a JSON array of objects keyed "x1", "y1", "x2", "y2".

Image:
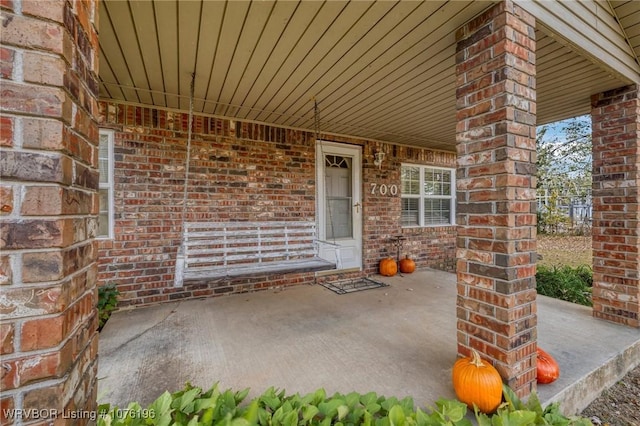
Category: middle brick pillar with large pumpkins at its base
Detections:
[{"x1": 456, "y1": 1, "x2": 537, "y2": 396}]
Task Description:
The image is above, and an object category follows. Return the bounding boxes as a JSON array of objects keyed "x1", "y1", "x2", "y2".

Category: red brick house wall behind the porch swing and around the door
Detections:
[{"x1": 99, "y1": 102, "x2": 455, "y2": 307}]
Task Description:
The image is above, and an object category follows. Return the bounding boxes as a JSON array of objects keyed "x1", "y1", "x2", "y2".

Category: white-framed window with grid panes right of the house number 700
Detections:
[{"x1": 401, "y1": 164, "x2": 456, "y2": 226}]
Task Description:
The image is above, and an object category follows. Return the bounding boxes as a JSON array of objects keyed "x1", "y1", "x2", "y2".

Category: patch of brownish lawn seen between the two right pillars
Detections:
[{"x1": 537, "y1": 235, "x2": 592, "y2": 267}]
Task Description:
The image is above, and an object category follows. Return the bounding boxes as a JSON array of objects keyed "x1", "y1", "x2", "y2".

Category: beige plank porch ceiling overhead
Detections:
[{"x1": 99, "y1": 0, "x2": 640, "y2": 150}]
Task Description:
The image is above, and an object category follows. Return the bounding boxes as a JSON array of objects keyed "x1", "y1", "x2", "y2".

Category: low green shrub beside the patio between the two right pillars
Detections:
[{"x1": 536, "y1": 265, "x2": 593, "y2": 306}]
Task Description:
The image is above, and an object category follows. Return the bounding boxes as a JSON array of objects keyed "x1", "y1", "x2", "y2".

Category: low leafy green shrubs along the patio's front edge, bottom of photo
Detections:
[{"x1": 98, "y1": 384, "x2": 591, "y2": 426}]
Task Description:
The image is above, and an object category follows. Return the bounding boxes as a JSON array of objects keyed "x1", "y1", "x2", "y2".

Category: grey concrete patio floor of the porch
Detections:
[{"x1": 98, "y1": 270, "x2": 640, "y2": 414}]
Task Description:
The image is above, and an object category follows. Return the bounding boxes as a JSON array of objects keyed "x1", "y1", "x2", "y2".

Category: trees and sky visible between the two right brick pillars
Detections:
[{"x1": 536, "y1": 116, "x2": 592, "y2": 233}]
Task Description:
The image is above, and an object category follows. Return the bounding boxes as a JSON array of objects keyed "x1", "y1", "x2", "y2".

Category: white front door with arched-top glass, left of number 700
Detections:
[{"x1": 316, "y1": 141, "x2": 362, "y2": 269}]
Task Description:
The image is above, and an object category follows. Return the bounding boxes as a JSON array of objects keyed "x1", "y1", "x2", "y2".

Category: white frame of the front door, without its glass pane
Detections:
[{"x1": 316, "y1": 140, "x2": 363, "y2": 270}]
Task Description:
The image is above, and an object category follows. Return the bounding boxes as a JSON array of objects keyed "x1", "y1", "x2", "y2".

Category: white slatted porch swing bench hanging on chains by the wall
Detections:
[{"x1": 174, "y1": 78, "x2": 341, "y2": 287}]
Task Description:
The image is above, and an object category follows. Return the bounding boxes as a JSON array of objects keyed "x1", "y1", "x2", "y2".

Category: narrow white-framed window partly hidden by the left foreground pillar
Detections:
[{"x1": 97, "y1": 130, "x2": 113, "y2": 238}]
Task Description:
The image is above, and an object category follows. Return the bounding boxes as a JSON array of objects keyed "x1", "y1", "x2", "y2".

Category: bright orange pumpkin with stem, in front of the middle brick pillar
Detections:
[{"x1": 452, "y1": 349, "x2": 502, "y2": 413}]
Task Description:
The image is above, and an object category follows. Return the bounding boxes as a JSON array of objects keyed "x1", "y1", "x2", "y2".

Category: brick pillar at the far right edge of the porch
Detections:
[{"x1": 591, "y1": 85, "x2": 640, "y2": 327}]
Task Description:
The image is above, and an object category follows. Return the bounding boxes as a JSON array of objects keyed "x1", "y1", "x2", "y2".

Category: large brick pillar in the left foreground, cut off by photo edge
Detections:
[{"x1": 0, "y1": 0, "x2": 98, "y2": 424}]
